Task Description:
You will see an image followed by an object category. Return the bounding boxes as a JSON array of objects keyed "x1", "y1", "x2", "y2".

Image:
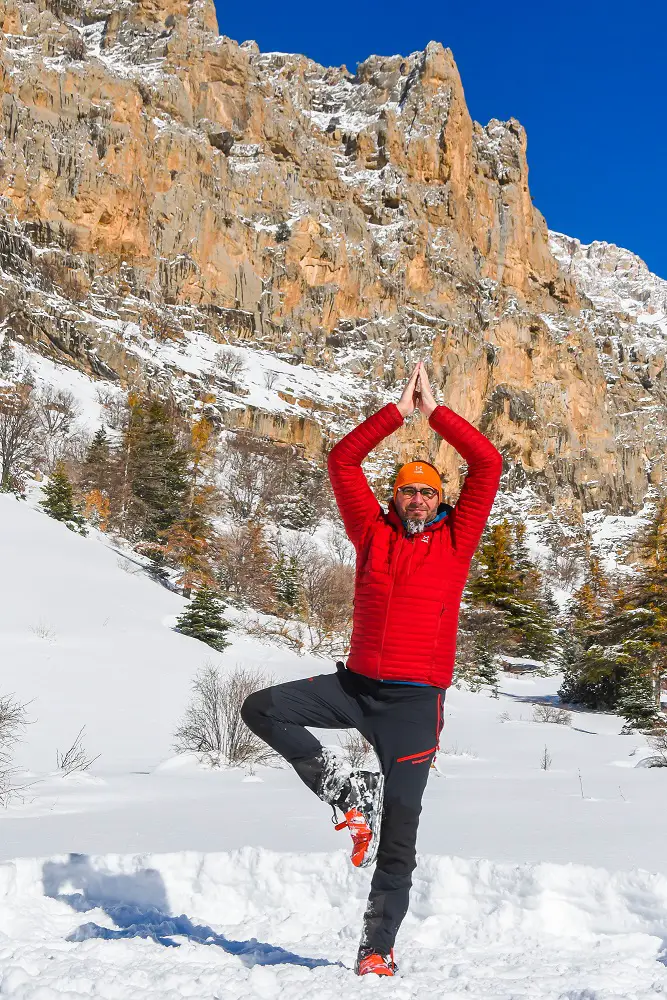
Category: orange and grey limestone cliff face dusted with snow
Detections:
[{"x1": 0, "y1": 0, "x2": 667, "y2": 518}]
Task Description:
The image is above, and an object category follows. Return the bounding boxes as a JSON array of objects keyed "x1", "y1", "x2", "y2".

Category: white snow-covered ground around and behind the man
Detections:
[{"x1": 0, "y1": 496, "x2": 667, "y2": 1000}]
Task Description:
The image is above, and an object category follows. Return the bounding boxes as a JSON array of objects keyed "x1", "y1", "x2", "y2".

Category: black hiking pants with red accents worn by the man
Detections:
[{"x1": 242, "y1": 663, "x2": 445, "y2": 955}]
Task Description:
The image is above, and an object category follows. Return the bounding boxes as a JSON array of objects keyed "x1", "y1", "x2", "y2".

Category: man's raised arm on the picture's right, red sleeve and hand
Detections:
[{"x1": 419, "y1": 368, "x2": 503, "y2": 559}]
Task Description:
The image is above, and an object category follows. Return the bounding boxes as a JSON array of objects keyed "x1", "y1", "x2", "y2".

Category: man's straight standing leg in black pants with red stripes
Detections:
[{"x1": 360, "y1": 685, "x2": 444, "y2": 956}]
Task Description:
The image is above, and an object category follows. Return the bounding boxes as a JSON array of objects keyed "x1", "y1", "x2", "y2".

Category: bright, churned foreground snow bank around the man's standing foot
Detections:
[{"x1": 0, "y1": 849, "x2": 667, "y2": 1000}]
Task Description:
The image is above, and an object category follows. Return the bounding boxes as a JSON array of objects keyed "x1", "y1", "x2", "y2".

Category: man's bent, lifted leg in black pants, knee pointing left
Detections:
[{"x1": 241, "y1": 671, "x2": 363, "y2": 801}]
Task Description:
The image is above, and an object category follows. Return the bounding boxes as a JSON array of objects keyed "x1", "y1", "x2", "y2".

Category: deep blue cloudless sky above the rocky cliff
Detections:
[{"x1": 217, "y1": 0, "x2": 667, "y2": 278}]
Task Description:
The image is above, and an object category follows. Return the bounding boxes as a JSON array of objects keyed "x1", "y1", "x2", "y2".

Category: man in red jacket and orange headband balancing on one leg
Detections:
[{"x1": 243, "y1": 362, "x2": 502, "y2": 976}]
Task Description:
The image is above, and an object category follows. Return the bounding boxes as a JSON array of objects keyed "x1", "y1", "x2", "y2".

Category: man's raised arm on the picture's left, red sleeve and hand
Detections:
[{"x1": 329, "y1": 365, "x2": 420, "y2": 545}]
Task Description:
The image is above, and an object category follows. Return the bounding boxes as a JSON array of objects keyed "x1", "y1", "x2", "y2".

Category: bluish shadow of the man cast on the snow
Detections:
[{"x1": 42, "y1": 854, "x2": 340, "y2": 969}]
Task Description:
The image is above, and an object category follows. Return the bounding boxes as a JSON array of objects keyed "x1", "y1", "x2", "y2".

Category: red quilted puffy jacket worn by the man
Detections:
[{"x1": 329, "y1": 403, "x2": 502, "y2": 688}]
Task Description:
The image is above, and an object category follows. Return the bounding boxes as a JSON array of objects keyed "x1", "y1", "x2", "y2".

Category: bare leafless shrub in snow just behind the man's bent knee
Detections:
[{"x1": 174, "y1": 662, "x2": 278, "y2": 767}]
